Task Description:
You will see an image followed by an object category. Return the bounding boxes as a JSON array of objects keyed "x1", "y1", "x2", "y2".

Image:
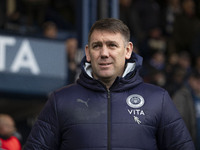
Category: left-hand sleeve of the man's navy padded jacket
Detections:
[{"x1": 24, "y1": 94, "x2": 59, "y2": 150}]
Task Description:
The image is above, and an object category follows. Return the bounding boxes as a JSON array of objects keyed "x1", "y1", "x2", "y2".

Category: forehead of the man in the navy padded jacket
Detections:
[{"x1": 90, "y1": 30, "x2": 124, "y2": 43}]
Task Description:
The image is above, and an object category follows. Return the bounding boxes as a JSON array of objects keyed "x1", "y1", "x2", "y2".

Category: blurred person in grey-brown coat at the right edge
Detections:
[{"x1": 173, "y1": 71, "x2": 200, "y2": 150}]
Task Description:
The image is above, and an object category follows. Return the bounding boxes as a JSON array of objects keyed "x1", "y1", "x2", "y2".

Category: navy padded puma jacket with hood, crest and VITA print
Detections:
[{"x1": 24, "y1": 54, "x2": 194, "y2": 150}]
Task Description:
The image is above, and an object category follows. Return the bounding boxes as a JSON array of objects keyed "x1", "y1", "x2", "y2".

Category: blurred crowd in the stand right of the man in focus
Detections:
[{"x1": 120, "y1": 0, "x2": 200, "y2": 150}]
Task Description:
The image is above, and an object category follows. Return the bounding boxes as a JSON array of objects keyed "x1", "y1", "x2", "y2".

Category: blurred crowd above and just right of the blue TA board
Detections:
[{"x1": 0, "y1": 0, "x2": 83, "y2": 84}]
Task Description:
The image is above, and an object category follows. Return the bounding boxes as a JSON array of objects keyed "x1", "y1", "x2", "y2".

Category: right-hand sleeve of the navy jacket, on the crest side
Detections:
[{"x1": 157, "y1": 91, "x2": 195, "y2": 150}]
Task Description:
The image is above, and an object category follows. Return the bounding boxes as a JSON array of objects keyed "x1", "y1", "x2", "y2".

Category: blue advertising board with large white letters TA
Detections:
[{"x1": 0, "y1": 35, "x2": 67, "y2": 95}]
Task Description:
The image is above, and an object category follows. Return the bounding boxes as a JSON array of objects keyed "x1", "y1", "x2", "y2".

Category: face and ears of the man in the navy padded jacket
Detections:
[{"x1": 85, "y1": 30, "x2": 133, "y2": 85}]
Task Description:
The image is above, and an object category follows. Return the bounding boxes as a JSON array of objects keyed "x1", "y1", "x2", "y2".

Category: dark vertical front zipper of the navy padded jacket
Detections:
[{"x1": 107, "y1": 90, "x2": 111, "y2": 150}]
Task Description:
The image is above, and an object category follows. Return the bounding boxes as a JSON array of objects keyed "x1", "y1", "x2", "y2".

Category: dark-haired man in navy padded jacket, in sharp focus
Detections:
[{"x1": 24, "y1": 18, "x2": 194, "y2": 150}]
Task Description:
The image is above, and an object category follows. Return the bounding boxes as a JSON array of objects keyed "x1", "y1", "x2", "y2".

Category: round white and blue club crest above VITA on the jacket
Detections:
[{"x1": 126, "y1": 94, "x2": 144, "y2": 108}]
